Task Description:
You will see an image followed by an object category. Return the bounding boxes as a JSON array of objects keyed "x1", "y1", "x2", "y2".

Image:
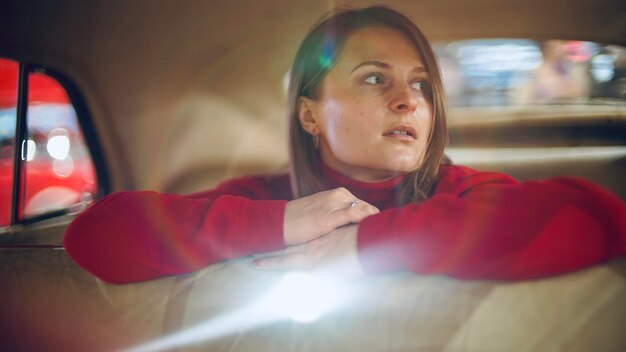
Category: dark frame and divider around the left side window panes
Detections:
[{"x1": 0, "y1": 58, "x2": 110, "y2": 248}]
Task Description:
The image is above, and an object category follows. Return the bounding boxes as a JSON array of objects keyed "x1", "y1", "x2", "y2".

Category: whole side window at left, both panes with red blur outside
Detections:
[{"x1": 0, "y1": 59, "x2": 98, "y2": 226}]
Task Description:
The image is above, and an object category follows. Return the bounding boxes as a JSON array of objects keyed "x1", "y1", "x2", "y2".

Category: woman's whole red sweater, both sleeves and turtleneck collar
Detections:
[{"x1": 65, "y1": 165, "x2": 626, "y2": 283}]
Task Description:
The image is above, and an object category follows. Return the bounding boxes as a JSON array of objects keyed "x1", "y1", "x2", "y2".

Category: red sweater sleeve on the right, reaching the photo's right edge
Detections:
[{"x1": 358, "y1": 169, "x2": 626, "y2": 280}]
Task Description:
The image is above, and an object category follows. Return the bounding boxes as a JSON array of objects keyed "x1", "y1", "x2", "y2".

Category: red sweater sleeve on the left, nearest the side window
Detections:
[{"x1": 64, "y1": 178, "x2": 287, "y2": 284}]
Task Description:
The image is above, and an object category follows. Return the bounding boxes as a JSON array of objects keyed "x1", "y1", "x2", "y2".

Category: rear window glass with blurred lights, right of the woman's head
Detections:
[{"x1": 434, "y1": 39, "x2": 626, "y2": 106}]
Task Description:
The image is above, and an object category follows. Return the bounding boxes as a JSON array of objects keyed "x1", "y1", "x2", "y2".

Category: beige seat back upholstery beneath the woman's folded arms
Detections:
[{"x1": 0, "y1": 250, "x2": 626, "y2": 352}]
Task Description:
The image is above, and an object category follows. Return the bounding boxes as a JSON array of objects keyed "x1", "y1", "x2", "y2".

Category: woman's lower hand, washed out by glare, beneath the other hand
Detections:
[{"x1": 253, "y1": 225, "x2": 365, "y2": 279}]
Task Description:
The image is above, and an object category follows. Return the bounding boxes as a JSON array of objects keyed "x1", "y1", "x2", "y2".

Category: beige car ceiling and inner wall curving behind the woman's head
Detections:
[{"x1": 0, "y1": 0, "x2": 626, "y2": 191}]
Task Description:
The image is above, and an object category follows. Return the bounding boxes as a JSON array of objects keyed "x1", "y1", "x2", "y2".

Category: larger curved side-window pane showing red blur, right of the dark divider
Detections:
[{"x1": 23, "y1": 73, "x2": 97, "y2": 218}]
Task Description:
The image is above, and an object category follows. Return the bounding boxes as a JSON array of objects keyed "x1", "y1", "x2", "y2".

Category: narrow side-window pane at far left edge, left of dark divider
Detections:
[{"x1": 0, "y1": 58, "x2": 19, "y2": 227}]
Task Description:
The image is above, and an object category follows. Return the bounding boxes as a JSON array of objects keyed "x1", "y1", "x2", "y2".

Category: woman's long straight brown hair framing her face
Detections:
[{"x1": 287, "y1": 6, "x2": 447, "y2": 204}]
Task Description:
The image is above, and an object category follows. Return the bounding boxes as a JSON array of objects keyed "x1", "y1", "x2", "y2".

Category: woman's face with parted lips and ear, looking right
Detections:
[{"x1": 299, "y1": 27, "x2": 432, "y2": 182}]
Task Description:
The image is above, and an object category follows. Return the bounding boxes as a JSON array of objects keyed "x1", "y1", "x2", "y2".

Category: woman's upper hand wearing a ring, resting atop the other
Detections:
[{"x1": 283, "y1": 187, "x2": 379, "y2": 246}]
